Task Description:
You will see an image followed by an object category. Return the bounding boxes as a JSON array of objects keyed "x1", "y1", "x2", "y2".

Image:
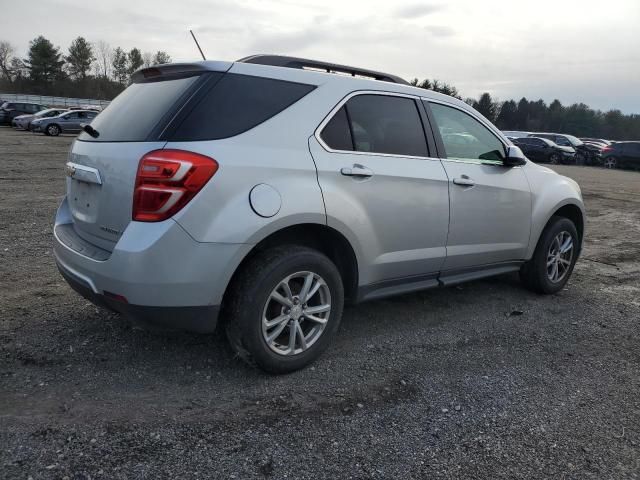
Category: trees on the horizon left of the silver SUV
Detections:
[{"x1": 0, "y1": 35, "x2": 171, "y2": 100}]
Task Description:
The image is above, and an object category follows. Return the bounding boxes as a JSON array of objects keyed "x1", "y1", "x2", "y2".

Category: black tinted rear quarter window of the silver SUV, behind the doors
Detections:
[{"x1": 172, "y1": 73, "x2": 315, "y2": 141}]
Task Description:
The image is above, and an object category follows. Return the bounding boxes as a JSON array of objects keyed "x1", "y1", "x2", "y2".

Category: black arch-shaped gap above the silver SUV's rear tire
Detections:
[{"x1": 222, "y1": 223, "x2": 358, "y2": 305}]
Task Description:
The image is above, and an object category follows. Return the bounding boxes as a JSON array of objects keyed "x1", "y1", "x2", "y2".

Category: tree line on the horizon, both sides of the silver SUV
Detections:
[{"x1": 0, "y1": 36, "x2": 640, "y2": 140}]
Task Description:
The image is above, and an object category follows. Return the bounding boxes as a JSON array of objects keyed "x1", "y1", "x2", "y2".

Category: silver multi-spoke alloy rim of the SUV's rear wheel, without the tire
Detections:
[{"x1": 262, "y1": 271, "x2": 331, "y2": 355}]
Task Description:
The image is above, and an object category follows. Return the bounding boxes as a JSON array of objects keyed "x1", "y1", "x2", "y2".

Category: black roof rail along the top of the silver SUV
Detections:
[{"x1": 236, "y1": 55, "x2": 409, "y2": 85}]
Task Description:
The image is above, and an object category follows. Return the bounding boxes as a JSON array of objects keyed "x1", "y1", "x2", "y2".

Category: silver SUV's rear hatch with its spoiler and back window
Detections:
[{"x1": 67, "y1": 62, "x2": 231, "y2": 251}]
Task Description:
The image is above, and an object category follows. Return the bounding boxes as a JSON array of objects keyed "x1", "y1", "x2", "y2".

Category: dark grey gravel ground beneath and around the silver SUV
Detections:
[{"x1": 0, "y1": 128, "x2": 640, "y2": 479}]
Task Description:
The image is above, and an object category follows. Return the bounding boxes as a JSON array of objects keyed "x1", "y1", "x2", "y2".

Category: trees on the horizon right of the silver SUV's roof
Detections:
[{"x1": 411, "y1": 78, "x2": 640, "y2": 140}]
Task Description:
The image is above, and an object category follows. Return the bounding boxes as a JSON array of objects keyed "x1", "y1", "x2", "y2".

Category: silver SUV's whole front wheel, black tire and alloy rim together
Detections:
[{"x1": 520, "y1": 216, "x2": 580, "y2": 295}]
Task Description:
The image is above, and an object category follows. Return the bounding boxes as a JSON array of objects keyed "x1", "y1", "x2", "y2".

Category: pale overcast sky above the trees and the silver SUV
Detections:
[{"x1": 5, "y1": 0, "x2": 640, "y2": 113}]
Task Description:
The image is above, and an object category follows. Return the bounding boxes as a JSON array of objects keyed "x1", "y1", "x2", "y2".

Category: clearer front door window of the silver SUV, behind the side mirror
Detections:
[{"x1": 430, "y1": 103, "x2": 505, "y2": 163}]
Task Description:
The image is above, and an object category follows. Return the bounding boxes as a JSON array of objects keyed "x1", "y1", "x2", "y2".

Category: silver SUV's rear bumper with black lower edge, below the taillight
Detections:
[{"x1": 54, "y1": 199, "x2": 251, "y2": 332}]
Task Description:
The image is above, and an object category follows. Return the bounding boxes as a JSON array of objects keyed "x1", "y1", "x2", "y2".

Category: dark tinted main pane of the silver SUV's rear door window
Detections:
[{"x1": 346, "y1": 95, "x2": 428, "y2": 157}]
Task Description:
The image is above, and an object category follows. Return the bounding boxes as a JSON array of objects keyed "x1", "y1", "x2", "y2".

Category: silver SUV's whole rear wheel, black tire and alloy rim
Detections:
[{"x1": 225, "y1": 245, "x2": 344, "y2": 373}]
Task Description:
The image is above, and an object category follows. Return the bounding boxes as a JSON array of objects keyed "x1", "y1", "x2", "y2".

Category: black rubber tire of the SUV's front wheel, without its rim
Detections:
[{"x1": 520, "y1": 216, "x2": 580, "y2": 295}]
